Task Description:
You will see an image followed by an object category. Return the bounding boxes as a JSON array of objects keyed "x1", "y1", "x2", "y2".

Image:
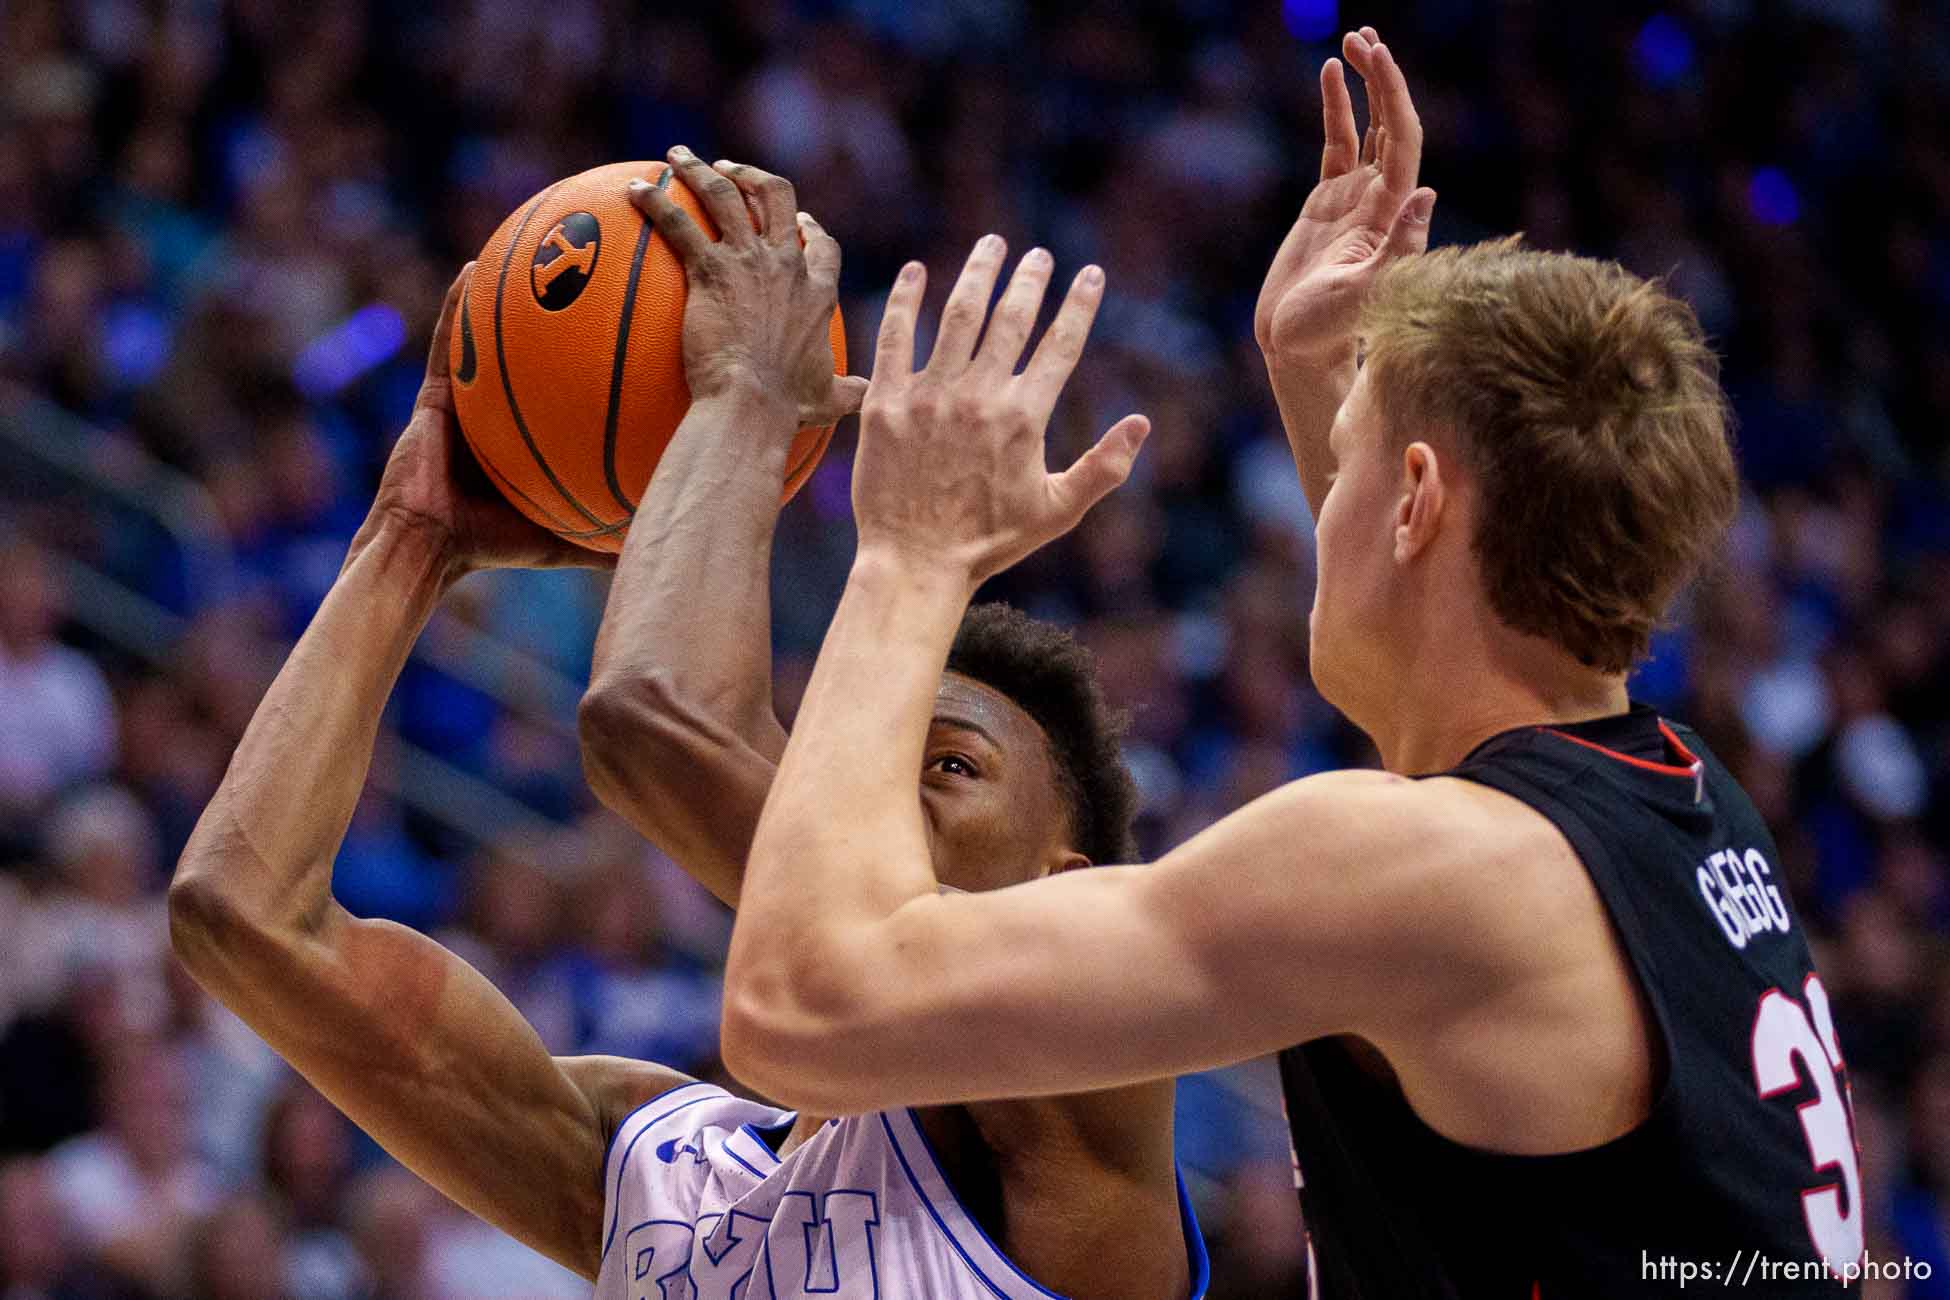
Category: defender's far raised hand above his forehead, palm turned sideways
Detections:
[{"x1": 1254, "y1": 27, "x2": 1435, "y2": 363}]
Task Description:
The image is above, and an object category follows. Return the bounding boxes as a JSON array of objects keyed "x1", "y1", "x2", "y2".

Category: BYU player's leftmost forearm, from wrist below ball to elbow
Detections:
[{"x1": 172, "y1": 520, "x2": 449, "y2": 951}]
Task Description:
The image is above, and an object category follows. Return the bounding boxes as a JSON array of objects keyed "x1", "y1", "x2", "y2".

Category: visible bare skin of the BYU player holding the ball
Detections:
[{"x1": 170, "y1": 150, "x2": 1190, "y2": 1300}]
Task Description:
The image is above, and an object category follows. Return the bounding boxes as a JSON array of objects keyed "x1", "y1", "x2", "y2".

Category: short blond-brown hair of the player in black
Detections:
[{"x1": 1361, "y1": 236, "x2": 1739, "y2": 672}]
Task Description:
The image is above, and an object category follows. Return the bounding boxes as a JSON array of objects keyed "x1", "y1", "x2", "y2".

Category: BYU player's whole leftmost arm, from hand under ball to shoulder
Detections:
[{"x1": 170, "y1": 273, "x2": 683, "y2": 1277}]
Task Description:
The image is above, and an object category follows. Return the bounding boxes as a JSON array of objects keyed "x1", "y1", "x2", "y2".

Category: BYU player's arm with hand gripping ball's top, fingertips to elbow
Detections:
[{"x1": 581, "y1": 148, "x2": 866, "y2": 904}]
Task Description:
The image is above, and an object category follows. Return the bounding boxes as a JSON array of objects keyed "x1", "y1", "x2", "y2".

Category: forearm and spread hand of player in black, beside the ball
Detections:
[{"x1": 723, "y1": 236, "x2": 1151, "y2": 1086}]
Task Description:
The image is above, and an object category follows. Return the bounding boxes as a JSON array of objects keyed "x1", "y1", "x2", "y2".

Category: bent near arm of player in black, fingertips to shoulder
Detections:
[{"x1": 722, "y1": 236, "x2": 1521, "y2": 1113}]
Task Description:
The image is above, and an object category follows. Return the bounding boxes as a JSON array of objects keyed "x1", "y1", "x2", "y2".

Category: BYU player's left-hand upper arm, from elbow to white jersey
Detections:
[{"x1": 172, "y1": 880, "x2": 684, "y2": 1279}]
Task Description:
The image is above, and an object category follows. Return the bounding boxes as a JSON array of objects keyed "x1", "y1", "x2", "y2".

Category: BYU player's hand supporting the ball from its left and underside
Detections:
[{"x1": 347, "y1": 261, "x2": 616, "y2": 577}]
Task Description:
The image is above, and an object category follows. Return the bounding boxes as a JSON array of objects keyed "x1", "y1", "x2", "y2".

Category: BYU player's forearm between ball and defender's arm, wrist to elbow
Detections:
[{"x1": 581, "y1": 383, "x2": 796, "y2": 902}]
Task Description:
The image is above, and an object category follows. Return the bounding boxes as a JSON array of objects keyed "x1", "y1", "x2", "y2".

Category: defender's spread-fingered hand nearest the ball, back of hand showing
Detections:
[{"x1": 852, "y1": 234, "x2": 1151, "y2": 589}]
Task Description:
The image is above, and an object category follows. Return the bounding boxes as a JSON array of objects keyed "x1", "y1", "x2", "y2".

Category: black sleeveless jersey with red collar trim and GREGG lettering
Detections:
[{"x1": 1281, "y1": 707, "x2": 1862, "y2": 1300}]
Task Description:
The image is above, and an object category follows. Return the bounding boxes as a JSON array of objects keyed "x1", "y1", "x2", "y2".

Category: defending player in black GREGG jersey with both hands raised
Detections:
[{"x1": 723, "y1": 29, "x2": 1862, "y2": 1300}]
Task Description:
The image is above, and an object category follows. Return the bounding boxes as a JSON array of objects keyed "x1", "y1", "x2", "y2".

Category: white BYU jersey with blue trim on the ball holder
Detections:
[{"x1": 595, "y1": 1084, "x2": 1209, "y2": 1300}]
